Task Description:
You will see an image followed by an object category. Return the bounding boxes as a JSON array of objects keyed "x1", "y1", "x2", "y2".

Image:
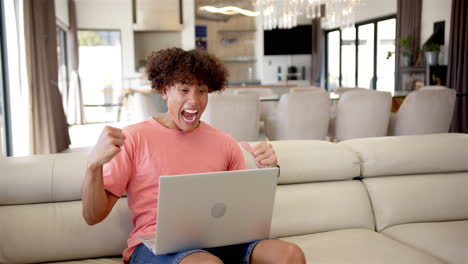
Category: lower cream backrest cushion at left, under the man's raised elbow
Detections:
[{"x1": 0, "y1": 198, "x2": 132, "y2": 263}]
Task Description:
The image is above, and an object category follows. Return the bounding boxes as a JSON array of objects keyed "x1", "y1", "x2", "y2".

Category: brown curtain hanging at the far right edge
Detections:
[{"x1": 447, "y1": 0, "x2": 468, "y2": 133}]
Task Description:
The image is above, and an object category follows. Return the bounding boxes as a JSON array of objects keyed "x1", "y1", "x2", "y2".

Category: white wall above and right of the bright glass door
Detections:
[{"x1": 76, "y1": 0, "x2": 135, "y2": 78}]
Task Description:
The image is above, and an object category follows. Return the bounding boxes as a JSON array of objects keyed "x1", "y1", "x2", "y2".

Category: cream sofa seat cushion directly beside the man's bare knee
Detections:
[{"x1": 281, "y1": 229, "x2": 444, "y2": 264}]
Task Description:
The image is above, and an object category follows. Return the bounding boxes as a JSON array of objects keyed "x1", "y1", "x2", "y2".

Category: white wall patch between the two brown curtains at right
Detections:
[{"x1": 420, "y1": 0, "x2": 452, "y2": 64}]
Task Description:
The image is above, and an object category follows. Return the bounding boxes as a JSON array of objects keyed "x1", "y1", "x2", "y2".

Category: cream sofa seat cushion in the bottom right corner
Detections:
[{"x1": 382, "y1": 220, "x2": 468, "y2": 264}]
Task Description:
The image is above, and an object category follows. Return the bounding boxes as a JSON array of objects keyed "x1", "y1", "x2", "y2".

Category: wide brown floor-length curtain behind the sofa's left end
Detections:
[{"x1": 24, "y1": 0, "x2": 70, "y2": 154}]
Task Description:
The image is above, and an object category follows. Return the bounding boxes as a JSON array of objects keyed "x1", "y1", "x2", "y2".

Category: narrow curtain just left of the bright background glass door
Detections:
[{"x1": 67, "y1": 0, "x2": 84, "y2": 124}]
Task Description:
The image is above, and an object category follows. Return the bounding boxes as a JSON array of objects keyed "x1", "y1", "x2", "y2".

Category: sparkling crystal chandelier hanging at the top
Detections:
[{"x1": 256, "y1": 0, "x2": 361, "y2": 30}]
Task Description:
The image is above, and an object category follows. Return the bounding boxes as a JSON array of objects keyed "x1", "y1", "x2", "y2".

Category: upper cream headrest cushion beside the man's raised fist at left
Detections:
[{"x1": 0, "y1": 152, "x2": 88, "y2": 205}]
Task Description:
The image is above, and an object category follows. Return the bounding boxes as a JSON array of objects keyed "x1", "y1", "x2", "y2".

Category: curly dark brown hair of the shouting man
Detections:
[{"x1": 146, "y1": 48, "x2": 229, "y2": 93}]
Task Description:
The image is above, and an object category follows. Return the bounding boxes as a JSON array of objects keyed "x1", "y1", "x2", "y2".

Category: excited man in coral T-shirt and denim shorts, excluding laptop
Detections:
[{"x1": 82, "y1": 48, "x2": 305, "y2": 263}]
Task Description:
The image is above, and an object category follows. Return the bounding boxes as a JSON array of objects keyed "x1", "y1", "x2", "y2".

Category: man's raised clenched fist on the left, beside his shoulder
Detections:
[{"x1": 88, "y1": 126, "x2": 125, "y2": 168}]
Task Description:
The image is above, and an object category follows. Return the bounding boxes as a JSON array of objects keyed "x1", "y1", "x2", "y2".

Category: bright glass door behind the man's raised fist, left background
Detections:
[{"x1": 78, "y1": 30, "x2": 122, "y2": 123}]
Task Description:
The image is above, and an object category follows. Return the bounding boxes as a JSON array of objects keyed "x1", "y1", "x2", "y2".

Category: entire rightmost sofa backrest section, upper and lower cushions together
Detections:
[{"x1": 339, "y1": 134, "x2": 468, "y2": 231}]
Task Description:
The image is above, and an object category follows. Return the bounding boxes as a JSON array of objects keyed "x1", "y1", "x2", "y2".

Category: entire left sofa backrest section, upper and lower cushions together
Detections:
[{"x1": 0, "y1": 153, "x2": 131, "y2": 263}]
